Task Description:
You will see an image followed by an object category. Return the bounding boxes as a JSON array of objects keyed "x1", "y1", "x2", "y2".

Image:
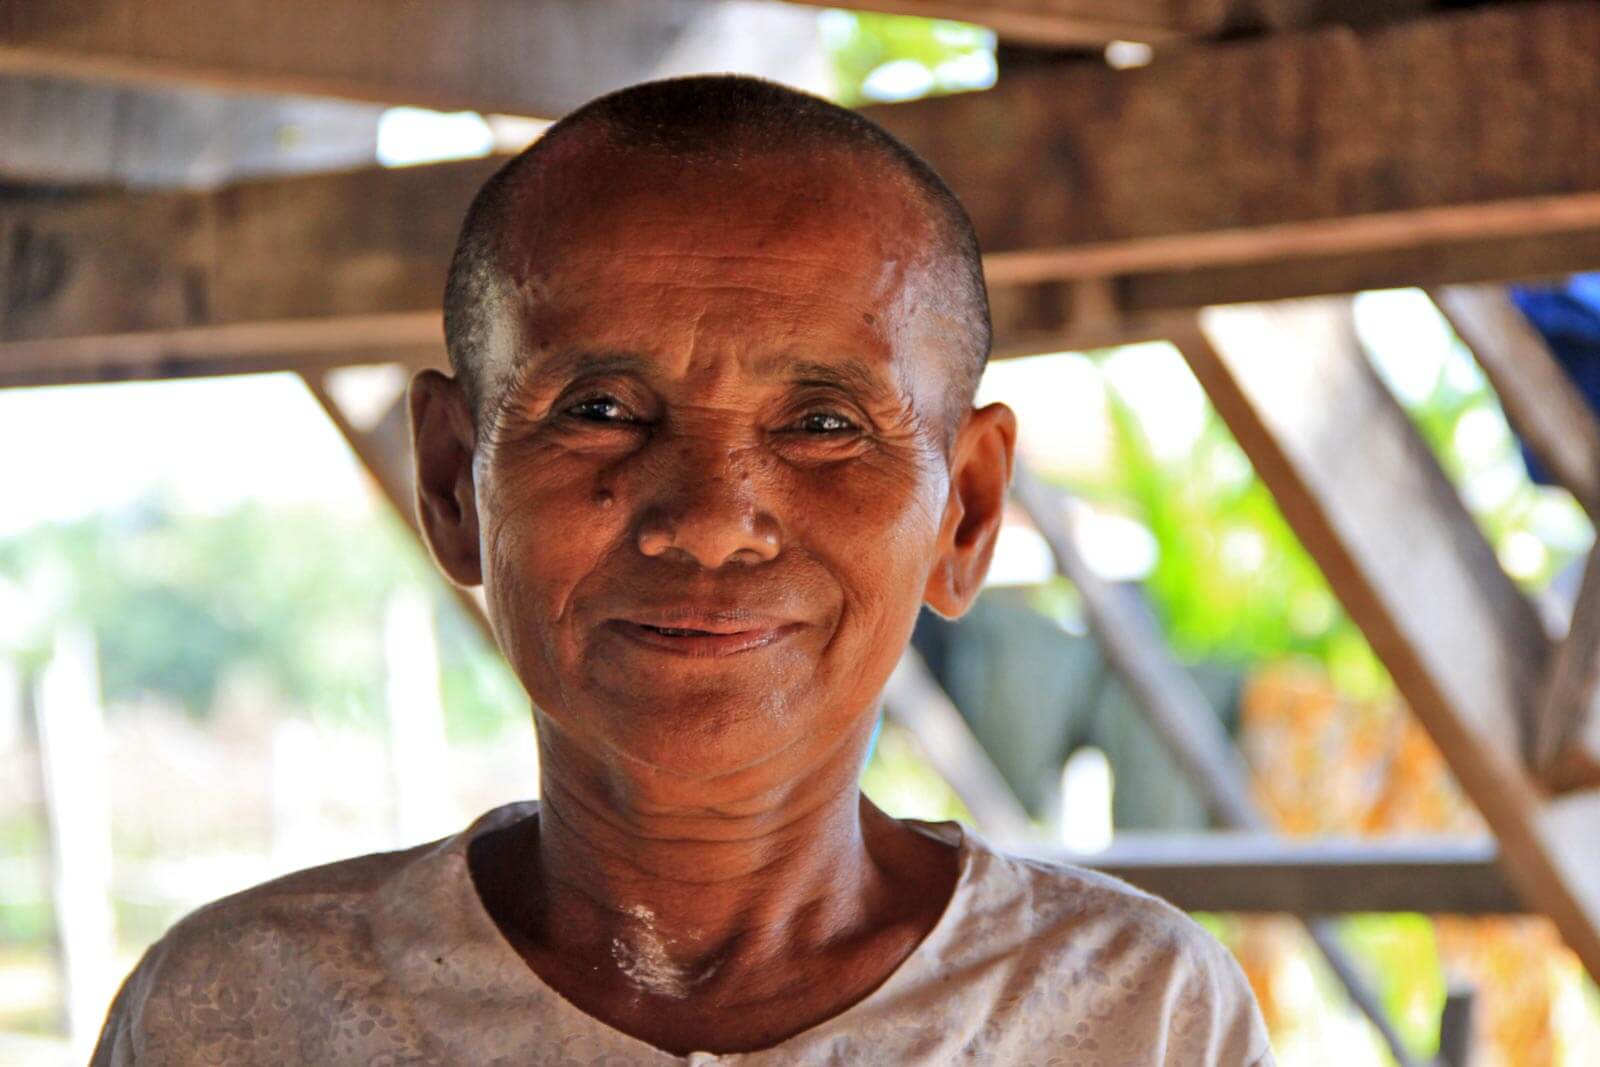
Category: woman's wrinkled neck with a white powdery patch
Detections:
[{"x1": 530, "y1": 720, "x2": 891, "y2": 998}]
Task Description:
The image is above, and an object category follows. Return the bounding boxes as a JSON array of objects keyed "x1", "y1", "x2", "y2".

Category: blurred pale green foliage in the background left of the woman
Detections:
[{"x1": 0, "y1": 501, "x2": 528, "y2": 737}]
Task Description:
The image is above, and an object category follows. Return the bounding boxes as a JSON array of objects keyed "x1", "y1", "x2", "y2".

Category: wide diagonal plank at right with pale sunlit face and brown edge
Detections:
[{"x1": 1174, "y1": 301, "x2": 1600, "y2": 974}]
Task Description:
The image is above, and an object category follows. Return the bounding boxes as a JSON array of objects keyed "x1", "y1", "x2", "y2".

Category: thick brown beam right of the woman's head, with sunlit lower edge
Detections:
[{"x1": 866, "y1": 0, "x2": 1600, "y2": 267}]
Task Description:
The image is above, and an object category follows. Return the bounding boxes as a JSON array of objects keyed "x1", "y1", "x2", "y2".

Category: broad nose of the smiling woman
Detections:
[{"x1": 638, "y1": 445, "x2": 781, "y2": 569}]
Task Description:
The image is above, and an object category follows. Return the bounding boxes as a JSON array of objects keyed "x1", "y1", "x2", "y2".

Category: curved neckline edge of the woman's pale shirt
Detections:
[{"x1": 440, "y1": 800, "x2": 978, "y2": 1064}]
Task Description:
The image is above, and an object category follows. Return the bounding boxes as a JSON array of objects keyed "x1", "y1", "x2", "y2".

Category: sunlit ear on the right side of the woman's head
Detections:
[{"x1": 923, "y1": 403, "x2": 1016, "y2": 619}]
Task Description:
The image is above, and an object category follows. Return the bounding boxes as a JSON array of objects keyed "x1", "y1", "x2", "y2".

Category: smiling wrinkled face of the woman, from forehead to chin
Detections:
[{"x1": 419, "y1": 141, "x2": 1004, "y2": 777}]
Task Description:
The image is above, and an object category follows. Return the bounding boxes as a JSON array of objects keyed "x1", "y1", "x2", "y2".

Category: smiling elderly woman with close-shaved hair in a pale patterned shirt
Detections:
[{"x1": 94, "y1": 77, "x2": 1272, "y2": 1067}]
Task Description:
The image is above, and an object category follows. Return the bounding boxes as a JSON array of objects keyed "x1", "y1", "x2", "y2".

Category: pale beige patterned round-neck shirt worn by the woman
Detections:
[{"x1": 93, "y1": 801, "x2": 1274, "y2": 1067}]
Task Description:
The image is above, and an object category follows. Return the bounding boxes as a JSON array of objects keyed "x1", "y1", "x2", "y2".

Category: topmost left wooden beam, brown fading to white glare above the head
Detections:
[{"x1": 0, "y1": 0, "x2": 826, "y2": 118}]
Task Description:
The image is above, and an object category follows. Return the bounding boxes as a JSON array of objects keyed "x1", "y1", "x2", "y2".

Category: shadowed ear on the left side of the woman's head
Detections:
[{"x1": 406, "y1": 370, "x2": 483, "y2": 585}]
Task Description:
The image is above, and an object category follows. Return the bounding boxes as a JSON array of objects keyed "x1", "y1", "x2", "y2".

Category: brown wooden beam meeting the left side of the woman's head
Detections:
[{"x1": 0, "y1": 158, "x2": 504, "y2": 341}]
